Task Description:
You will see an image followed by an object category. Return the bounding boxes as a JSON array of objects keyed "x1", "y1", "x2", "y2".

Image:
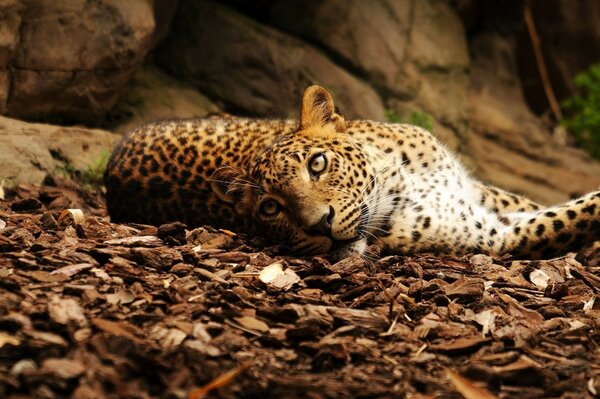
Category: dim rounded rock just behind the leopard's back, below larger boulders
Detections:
[{"x1": 106, "y1": 65, "x2": 219, "y2": 132}]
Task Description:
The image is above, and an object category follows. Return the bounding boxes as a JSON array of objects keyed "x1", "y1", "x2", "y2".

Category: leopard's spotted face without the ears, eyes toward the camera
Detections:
[{"x1": 250, "y1": 130, "x2": 374, "y2": 258}]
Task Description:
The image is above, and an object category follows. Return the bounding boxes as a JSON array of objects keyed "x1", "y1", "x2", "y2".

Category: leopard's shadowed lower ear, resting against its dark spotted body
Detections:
[{"x1": 209, "y1": 166, "x2": 253, "y2": 214}]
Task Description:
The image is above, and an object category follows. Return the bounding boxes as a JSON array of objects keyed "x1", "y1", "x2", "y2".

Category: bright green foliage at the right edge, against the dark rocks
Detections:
[{"x1": 561, "y1": 64, "x2": 600, "y2": 159}]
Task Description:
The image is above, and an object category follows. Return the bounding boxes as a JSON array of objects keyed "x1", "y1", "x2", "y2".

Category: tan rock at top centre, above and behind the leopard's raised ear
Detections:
[{"x1": 245, "y1": 0, "x2": 415, "y2": 97}]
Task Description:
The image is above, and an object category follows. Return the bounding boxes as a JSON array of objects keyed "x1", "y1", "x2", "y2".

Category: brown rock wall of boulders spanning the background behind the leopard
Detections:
[{"x1": 0, "y1": 0, "x2": 600, "y2": 202}]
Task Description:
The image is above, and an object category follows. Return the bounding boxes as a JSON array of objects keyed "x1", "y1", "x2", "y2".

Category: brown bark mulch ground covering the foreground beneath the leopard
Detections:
[{"x1": 0, "y1": 178, "x2": 600, "y2": 399}]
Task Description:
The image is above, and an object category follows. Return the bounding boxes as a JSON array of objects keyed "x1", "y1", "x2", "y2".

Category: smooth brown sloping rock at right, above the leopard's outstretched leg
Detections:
[{"x1": 468, "y1": 34, "x2": 600, "y2": 204}]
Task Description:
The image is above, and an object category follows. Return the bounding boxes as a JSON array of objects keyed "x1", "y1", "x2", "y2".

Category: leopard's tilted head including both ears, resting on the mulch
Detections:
[{"x1": 213, "y1": 86, "x2": 375, "y2": 258}]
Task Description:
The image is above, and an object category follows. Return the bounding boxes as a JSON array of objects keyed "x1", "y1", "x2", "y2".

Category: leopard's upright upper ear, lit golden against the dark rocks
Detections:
[{"x1": 300, "y1": 85, "x2": 346, "y2": 132}]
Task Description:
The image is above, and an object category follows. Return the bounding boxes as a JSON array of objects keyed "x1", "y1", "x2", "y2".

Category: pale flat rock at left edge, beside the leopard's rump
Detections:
[{"x1": 0, "y1": 116, "x2": 120, "y2": 184}]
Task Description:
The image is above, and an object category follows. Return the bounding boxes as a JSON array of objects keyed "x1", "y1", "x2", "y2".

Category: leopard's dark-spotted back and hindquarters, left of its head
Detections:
[{"x1": 105, "y1": 116, "x2": 294, "y2": 229}]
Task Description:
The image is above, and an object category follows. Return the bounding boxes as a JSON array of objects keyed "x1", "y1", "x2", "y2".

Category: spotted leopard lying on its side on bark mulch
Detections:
[{"x1": 105, "y1": 85, "x2": 600, "y2": 259}]
